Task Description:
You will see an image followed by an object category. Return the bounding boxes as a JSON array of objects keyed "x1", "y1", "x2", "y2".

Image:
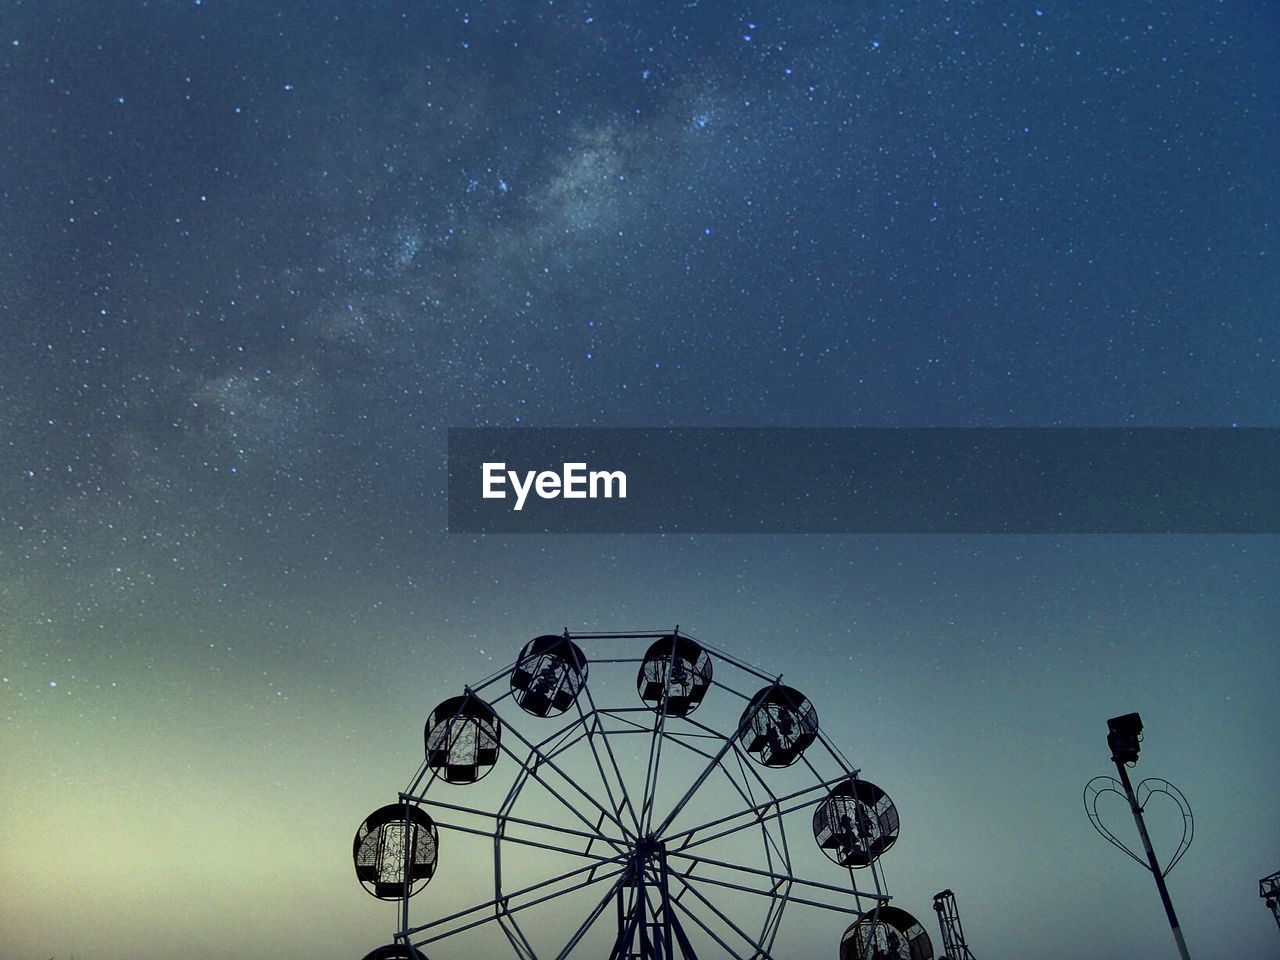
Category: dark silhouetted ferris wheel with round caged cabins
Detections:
[{"x1": 352, "y1": 627, "x2": 933, "y2": 960}]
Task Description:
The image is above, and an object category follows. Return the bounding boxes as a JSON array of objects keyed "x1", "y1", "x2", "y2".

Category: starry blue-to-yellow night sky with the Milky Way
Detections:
[{"x1": 0, "y1": 0, "x2": 1280, "y2": 960}]
